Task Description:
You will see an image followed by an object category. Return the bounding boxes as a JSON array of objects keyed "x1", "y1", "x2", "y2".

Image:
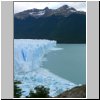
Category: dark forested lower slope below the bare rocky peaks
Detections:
[{"x1": 14, "y1": 13, "x2": 86, "y2": 43}]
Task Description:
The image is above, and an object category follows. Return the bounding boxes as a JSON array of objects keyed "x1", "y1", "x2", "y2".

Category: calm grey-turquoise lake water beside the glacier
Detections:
[{"x1": 43, "y1": 44, "x2": 86, "y2": 84}]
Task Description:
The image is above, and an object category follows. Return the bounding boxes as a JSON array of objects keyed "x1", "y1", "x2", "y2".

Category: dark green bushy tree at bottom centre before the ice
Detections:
[{"x1": 26, "y1": 85, "x2": 49, "y2": 98}]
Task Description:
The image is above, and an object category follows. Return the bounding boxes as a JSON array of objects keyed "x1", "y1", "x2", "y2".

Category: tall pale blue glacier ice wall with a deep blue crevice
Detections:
[{"x1": 14, "y1": 39, "x2": 56, "y2": 73}]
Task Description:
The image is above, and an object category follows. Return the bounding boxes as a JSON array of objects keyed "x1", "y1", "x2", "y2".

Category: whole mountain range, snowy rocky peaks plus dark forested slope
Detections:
[{"x1": 14, "y1": 5, "x2": 86, "y2": 43}]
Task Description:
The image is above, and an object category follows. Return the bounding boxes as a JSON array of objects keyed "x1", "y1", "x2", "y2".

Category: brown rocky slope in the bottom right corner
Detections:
[{"x1": 55, "y1": 85, "x2": 86, "y2": 98}]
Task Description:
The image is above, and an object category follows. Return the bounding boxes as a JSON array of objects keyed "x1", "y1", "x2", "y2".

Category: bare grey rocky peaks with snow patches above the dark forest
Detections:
[{"x1": 15, "y1": 5, "x2": 85, "y2": 19}]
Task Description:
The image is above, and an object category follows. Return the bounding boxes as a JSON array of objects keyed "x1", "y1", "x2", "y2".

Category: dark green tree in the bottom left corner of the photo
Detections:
[{"x1": 14, "y1": 80, "x2": 22, "y2": 98}]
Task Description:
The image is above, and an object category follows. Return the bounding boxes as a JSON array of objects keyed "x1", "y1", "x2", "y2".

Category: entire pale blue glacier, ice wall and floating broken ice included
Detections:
[{"x1": 14, "y1": 39, "x2": 77, "y2": 97}]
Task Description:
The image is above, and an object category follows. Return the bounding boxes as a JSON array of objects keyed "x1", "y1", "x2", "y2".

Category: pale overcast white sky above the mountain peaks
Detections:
[{"x1": 14, "y1": 2, "x2": 86, "y2": 13}]
